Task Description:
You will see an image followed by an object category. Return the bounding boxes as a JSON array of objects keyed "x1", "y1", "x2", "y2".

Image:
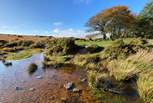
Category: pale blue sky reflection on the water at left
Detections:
[{"x1": 0, "y1": 54, "x2": 44, "y2": 90}]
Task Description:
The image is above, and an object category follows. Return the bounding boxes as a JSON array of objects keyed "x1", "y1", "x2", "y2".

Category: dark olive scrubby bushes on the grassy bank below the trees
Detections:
[{"x1": 102, "y1": 39, "x2": 147, "y2": 60}]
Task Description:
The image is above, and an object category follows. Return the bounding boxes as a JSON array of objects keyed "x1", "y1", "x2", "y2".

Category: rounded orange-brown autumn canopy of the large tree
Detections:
[{"x1": 87, "y1": 6, "x2": 135, "y2": 39}]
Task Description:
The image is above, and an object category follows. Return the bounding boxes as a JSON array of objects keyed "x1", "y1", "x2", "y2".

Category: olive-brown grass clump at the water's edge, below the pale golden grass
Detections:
[{"x1": 88, "y1": 70, "x2": 125, "y2": 103}]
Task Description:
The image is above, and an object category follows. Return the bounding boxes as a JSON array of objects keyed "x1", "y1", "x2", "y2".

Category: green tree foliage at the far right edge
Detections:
[{"x1": 137, "y1": 1, "x2": 153, "y2": 38}]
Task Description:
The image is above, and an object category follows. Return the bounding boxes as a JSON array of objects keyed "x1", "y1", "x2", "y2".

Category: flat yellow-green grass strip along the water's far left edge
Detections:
[{"x1": 6, "y1": 49, "x2": 41, "y2": 60}]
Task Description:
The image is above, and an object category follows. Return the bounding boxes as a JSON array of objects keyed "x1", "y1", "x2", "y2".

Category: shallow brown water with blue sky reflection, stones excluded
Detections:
[{"x1": 0, "y1": 54, "x2": 92, "y2": 103}]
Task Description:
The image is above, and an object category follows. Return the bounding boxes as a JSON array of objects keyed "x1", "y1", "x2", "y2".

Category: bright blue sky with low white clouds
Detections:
[{"x1": 0, "y1": 0, "x2": 148, "y2": 37}]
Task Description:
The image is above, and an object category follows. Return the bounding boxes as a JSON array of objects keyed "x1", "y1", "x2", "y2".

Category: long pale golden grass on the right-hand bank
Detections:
[{"x1": 108, "y1": 50, "x2": 153, "y2": 103}]
